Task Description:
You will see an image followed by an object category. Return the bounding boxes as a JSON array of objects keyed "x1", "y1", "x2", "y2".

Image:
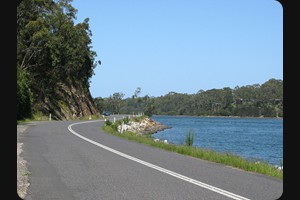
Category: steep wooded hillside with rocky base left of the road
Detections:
[{"x1": 17, "y1": 0, "x2": 100, "y2": 119}]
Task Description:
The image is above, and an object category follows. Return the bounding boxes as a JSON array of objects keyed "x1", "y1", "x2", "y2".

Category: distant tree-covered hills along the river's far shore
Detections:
[{"x1": 94, "y1": 79, "x2": 283, "y2": 117}]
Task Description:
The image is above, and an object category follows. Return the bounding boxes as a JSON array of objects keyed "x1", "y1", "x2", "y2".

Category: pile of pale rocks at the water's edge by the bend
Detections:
[{"x1": 118, "y1": 117, "x2": 171, "y2": 134}]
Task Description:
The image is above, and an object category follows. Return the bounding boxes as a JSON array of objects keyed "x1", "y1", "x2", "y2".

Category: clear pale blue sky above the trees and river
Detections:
[{"x1": 72, "y1": 0, "x2": 283, "y2": 98}]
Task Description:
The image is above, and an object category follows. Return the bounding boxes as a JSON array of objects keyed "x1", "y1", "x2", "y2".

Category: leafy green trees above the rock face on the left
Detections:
[{"x1": 17, "y1": 0, "x2": 100, "y2": 119}]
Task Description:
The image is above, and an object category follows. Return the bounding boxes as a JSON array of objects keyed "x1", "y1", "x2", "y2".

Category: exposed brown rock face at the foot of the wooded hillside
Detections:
[{"x1": 37, "y1": 84, "x2": 100, "y2": 120}]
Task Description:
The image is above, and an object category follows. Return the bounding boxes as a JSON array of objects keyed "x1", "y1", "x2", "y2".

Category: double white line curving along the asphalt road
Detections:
[{"x1": 68, "y1": 120, "x2": 250, "y2": 200}]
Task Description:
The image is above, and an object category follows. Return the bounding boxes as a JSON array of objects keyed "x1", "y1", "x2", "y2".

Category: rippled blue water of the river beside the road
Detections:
[{"x1": 151, "y1": 115, "x2": 283, "y2": 165}]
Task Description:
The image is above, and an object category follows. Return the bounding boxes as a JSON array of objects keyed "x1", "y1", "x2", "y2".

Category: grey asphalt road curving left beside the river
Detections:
[{"x1": 21, "y1": 116, "x2": 283, "y2": 200}]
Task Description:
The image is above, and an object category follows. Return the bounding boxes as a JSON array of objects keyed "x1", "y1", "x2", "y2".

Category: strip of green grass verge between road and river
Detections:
[{"x1": 102, "y1": 116, "x2": 283, "y2": 179}]
